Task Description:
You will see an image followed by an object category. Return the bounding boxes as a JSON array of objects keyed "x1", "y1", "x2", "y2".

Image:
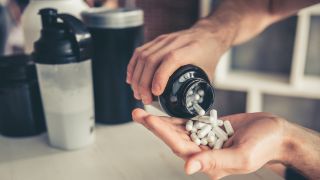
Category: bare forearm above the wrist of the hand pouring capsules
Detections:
[{"x1": 196, "y1": 0, "x2": 320, "y2": 48}]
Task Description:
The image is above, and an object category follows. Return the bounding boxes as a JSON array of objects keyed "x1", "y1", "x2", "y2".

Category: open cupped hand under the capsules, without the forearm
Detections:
[{"x1": 132, "y1": 109, "x2": 285, "y2": 179}]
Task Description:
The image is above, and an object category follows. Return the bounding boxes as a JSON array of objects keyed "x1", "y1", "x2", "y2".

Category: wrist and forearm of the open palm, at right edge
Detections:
[{"x1": 281, "y1": 122, "x2": 320, "y2": 179}]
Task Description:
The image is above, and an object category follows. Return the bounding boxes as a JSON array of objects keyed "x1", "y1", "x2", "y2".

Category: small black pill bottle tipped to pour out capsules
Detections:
[{"x1": 159, "y1": 65, "x2": 215, "y2": 118}]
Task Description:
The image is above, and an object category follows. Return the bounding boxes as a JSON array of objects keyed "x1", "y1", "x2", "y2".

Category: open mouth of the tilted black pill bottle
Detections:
[{"x1": 182, "y1": 79, "x2": 215, "y2": 116}]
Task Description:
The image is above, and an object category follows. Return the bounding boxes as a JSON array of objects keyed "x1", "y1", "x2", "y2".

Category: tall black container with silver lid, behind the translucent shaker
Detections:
[{"x1": 82, "y1": 8, "x2": 143, "y2": 124}]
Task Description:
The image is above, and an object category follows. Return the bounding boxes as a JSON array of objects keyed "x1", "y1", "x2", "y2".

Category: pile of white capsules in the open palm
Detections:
[{"x1": 186, "y1": 109, "x2": 234, "y2": 149}]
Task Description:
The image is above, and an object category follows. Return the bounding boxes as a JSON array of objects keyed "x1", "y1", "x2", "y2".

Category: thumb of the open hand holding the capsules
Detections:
[{"x1": 185, "y1": 148, "x2": 237, "y2": 178}]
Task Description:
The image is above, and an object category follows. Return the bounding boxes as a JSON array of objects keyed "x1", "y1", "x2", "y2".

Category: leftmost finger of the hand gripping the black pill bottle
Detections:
[{"x1": 126, "y1": 41, "x2": 157, "y2": 84}]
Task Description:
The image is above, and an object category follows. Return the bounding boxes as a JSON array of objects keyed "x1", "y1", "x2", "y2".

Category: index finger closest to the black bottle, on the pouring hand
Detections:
[{"x1": 152, "y1": 45, "x2": 190, "y2": 96}]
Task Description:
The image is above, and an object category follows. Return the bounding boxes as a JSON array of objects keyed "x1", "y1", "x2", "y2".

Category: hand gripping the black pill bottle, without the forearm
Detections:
[{"x1": 127, "y1": 22, "x2": 226, "y2": 104}]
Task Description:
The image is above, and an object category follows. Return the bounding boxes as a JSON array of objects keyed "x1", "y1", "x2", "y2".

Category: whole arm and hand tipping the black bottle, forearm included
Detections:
[{"x1": 127, "y1": 0, "x2": 320, "y2": 104}]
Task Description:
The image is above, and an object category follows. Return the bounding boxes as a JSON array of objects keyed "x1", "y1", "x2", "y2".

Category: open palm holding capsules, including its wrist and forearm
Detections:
[{"x1": 132, "y1": 109, "x2": 320, "y2": 180}]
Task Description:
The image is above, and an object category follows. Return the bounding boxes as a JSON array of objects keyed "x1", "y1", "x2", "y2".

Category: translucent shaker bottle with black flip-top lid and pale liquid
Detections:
[{"x1": 34, "y1": 9, "x2": 94, "y2": 150}]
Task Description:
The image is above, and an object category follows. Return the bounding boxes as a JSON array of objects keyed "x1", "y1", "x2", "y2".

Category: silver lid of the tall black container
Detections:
[{"x1": 81, "y1": 8, "x2": 144, "y2": 29}]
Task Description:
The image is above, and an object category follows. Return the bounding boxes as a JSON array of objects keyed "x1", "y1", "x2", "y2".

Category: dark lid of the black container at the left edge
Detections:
[{"x1": 0, "y1": 54, "x2": 36, "y2": 82}]
